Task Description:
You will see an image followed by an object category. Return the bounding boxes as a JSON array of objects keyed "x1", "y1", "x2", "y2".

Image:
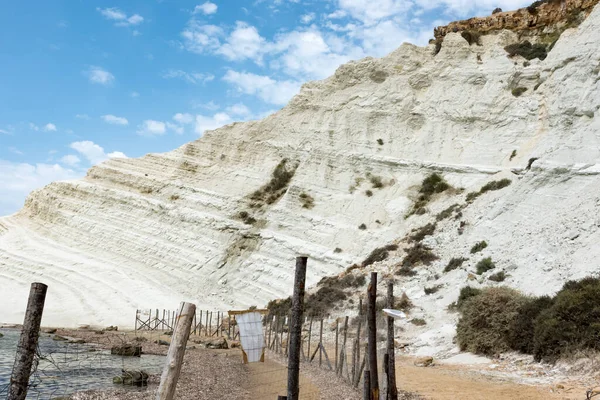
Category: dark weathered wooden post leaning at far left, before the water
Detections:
[{"x1": 6, "y1": 283, "x2": 48, "y2": 400}]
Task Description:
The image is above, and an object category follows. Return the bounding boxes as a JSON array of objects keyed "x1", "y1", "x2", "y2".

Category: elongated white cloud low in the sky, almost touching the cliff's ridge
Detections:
[{"x1": 223, "y1": 70, "x2": 301, "y2": 105}]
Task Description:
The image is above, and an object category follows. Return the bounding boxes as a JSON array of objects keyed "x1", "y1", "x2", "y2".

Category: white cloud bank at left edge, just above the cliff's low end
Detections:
[{"x1": 0, "y1": 160, "x2": 83, "y2": 215}]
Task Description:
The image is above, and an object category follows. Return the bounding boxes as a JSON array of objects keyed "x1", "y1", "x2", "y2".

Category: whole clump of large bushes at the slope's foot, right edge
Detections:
[{"x1": 456, "y1": 277, "x2": 600, "y2": 362}]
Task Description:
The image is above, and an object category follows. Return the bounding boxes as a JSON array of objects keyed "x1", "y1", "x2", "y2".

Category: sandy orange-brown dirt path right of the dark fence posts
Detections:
[{"x1": 396, "y1": 358, "x2": 586, "y2": 400}]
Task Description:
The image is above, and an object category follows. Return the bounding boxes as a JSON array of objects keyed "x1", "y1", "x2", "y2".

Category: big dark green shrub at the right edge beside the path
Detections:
[{"x1": 533, "y1": 278, "x2": 600, "y2": 361}]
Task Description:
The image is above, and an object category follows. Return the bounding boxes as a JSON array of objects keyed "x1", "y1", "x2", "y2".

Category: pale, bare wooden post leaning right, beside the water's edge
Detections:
[{"x1": 156, "y1": 303, "x2": 196, "y2": 400}]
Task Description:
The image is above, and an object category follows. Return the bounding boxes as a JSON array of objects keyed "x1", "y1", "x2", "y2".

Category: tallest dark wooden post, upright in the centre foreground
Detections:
[{"x1": 287, "y1": 257, "x2": 307, "y2": 400}]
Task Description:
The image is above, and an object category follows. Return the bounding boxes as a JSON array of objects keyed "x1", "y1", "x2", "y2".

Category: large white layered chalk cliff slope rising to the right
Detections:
[{"x1": 0, "y1": 8, "x2": 600, "y2": 340}]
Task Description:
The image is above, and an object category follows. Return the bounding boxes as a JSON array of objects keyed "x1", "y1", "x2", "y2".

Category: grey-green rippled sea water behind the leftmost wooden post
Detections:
[{"x1": 0, "y1": 329, "x2": 165, "y2": 399}]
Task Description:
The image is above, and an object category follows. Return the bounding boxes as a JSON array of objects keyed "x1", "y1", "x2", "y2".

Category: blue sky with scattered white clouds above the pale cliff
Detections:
[{"x1": 0, "y1": 0, "x2": 530, "y2": 215}]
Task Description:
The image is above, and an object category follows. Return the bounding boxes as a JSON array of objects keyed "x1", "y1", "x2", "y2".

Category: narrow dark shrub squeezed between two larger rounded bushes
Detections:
[{"x1": 508, "y1": 296, "x2": 552, "y2": 354}]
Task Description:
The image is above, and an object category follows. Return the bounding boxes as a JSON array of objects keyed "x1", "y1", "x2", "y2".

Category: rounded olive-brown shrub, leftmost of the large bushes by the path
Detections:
[{"x1": 456, "y1": 287, "x2": 527, "y2": 356}]
